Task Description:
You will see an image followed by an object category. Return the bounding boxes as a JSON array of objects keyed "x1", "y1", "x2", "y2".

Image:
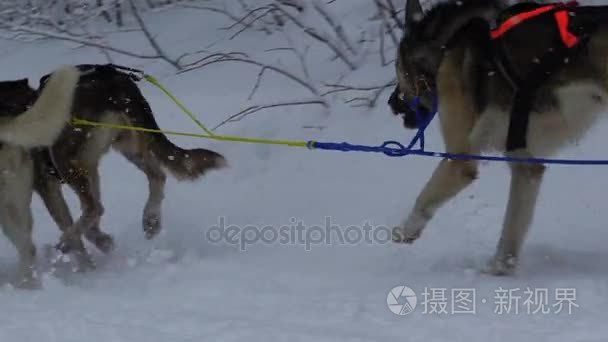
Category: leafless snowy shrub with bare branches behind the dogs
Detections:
[{"x1": 0, "y1": 0, "x2": 404, "y2": 127}]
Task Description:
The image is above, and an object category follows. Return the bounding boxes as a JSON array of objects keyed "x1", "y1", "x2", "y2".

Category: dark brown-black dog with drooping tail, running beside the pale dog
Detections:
[{"x1": 0, "y1": 64, "x2": 227, "y2": 269}]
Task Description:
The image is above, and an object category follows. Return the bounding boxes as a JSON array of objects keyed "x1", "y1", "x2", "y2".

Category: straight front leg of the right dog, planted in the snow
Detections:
[{"x1": 489, "y1": 152, "x2": 545, "y2": 275}]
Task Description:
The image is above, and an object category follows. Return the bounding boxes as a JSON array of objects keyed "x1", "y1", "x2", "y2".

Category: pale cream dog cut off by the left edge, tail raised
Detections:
[{"x1": 0, "y1": 67, "x2": 79, "y2": 287}]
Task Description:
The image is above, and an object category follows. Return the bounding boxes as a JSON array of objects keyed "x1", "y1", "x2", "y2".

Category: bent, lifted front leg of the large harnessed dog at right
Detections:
[{"x1": 393, "y1": 159, "x2": 477, "y2": 243}]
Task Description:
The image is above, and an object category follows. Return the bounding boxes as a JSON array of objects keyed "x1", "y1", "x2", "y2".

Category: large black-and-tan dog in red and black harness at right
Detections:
[{"x1": 389, "y1": 0, "x2": 608, "y2": 275}]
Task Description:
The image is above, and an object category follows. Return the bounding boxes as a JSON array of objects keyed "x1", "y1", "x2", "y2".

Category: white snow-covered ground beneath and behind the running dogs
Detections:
[{"x1": 0, "y1": 0, "x2": 608, "y2": 342}]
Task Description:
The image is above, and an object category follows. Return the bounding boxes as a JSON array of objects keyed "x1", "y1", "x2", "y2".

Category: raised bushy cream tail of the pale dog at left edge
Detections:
[{"x1": 0, "y1": 66, "x2": 80, "y2": 148}]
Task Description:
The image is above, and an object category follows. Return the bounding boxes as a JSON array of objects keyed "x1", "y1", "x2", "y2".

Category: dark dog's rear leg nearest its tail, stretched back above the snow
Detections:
[{"x1": 113, "y1": 134, "x2": 167, "y2": 239}]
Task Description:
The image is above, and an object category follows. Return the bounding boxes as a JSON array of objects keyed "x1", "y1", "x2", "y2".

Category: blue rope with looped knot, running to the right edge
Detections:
[{"x1": 307, "y1": 97, "x2": 608, "y2": 165}]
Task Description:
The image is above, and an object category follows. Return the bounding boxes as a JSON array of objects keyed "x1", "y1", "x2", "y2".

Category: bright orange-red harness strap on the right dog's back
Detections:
[{"x1": 490, "y1": 1, "x2": 580, "y2": 48}]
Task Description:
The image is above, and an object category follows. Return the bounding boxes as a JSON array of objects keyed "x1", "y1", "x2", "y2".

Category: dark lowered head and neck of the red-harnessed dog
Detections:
[{"x1": 388, "y1": 0, "x2": 497, "y2": 128}]
